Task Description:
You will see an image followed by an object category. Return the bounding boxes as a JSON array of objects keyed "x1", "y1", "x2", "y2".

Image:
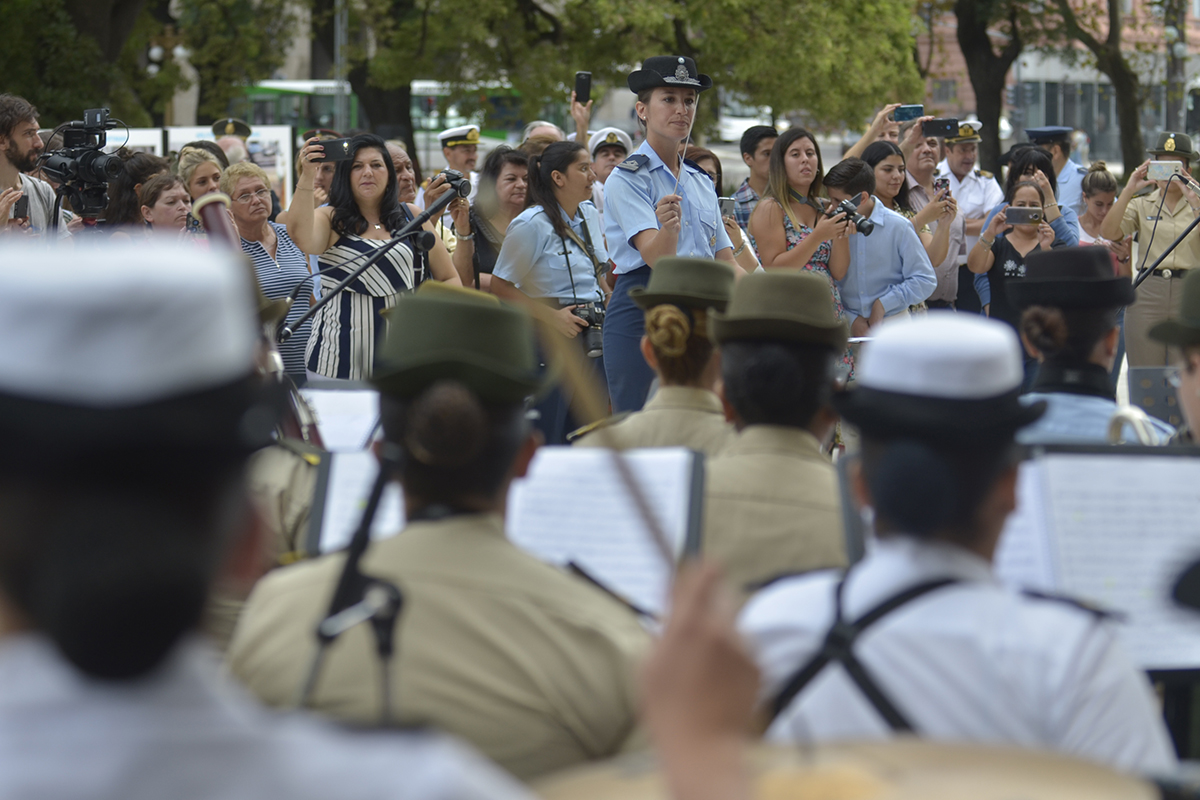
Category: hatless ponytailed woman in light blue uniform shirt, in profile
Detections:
[{"x1": 491, "y1": 142, "x2": 608, "y2": 444}]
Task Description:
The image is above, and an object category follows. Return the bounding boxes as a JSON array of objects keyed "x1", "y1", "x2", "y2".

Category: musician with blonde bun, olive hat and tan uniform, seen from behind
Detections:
[{"x1": 575, "y1": 258, "x2": 736, "y2": 456}]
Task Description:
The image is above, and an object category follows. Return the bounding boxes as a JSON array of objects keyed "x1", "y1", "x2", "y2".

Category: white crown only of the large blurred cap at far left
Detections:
[{"x1": 0, "y1": 241, "x2": 259, "y2": 409}]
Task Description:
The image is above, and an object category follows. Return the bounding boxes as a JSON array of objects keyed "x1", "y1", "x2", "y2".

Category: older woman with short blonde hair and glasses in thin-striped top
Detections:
[{"x1": 221, "y1": 161, "x2": 312, "y2": 385}]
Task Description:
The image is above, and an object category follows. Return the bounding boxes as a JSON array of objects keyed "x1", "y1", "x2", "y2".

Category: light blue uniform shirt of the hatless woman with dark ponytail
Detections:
[{"x1": 493, "y1": 200, "x2": 608, "y2": 303}]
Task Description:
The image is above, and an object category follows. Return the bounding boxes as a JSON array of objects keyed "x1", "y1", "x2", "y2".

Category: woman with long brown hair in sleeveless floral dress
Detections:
[{"x1": 750, "y1": 127, "x2": 853, "y2": 379}]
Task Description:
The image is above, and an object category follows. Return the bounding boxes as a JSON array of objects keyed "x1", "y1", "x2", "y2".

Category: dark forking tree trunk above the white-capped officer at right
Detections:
[{"x1": 954, "y1": 0, "x2": 1024, "y2": 175}]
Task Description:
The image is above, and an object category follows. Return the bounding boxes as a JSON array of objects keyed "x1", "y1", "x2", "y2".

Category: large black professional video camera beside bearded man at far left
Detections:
[{"x1": 41, "y1": 108, "x2": 125, "y2": 219}]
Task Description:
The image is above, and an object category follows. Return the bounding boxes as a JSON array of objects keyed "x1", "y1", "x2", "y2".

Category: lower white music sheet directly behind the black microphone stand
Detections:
[{"x1": 320, "y1": 450, "x2": 404, "y2": 553}]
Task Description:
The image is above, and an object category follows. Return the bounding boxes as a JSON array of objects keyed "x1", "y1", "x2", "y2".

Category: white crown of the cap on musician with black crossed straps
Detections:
[{"x1": 856, "y1": 312, "x2": 1025, "y2": 399}]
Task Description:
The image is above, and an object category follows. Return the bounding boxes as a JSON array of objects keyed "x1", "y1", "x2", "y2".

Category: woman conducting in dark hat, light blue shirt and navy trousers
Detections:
[{"x1": 604, "y1": 55, "x2": 740, "y2": 413}]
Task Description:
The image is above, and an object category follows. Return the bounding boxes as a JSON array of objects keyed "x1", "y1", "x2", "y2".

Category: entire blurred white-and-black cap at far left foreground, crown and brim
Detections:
[{"x1": 0, "y1": 242, "x2": 278, "y2": 463}]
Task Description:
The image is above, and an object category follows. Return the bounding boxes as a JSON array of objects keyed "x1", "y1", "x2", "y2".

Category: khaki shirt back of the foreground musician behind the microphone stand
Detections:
[{"x1": 229, "y1": 515, "x2": 649, "y2": 780}]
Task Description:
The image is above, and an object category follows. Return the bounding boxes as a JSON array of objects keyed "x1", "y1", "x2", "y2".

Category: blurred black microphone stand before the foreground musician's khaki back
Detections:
[{"x1": 296, "y1": 443, "x2": 404, "y2": 726}]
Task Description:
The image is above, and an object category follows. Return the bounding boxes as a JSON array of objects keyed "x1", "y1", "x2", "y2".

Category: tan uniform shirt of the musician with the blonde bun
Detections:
[{"x1": 575, "y1": 386, "x2": 737, "y2": 456}]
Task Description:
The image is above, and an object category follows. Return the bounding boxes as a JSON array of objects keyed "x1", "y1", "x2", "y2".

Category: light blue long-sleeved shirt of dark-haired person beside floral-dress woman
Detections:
[{"x1": 838, "y1": 196, "x2": 937, "y2": 321}]
